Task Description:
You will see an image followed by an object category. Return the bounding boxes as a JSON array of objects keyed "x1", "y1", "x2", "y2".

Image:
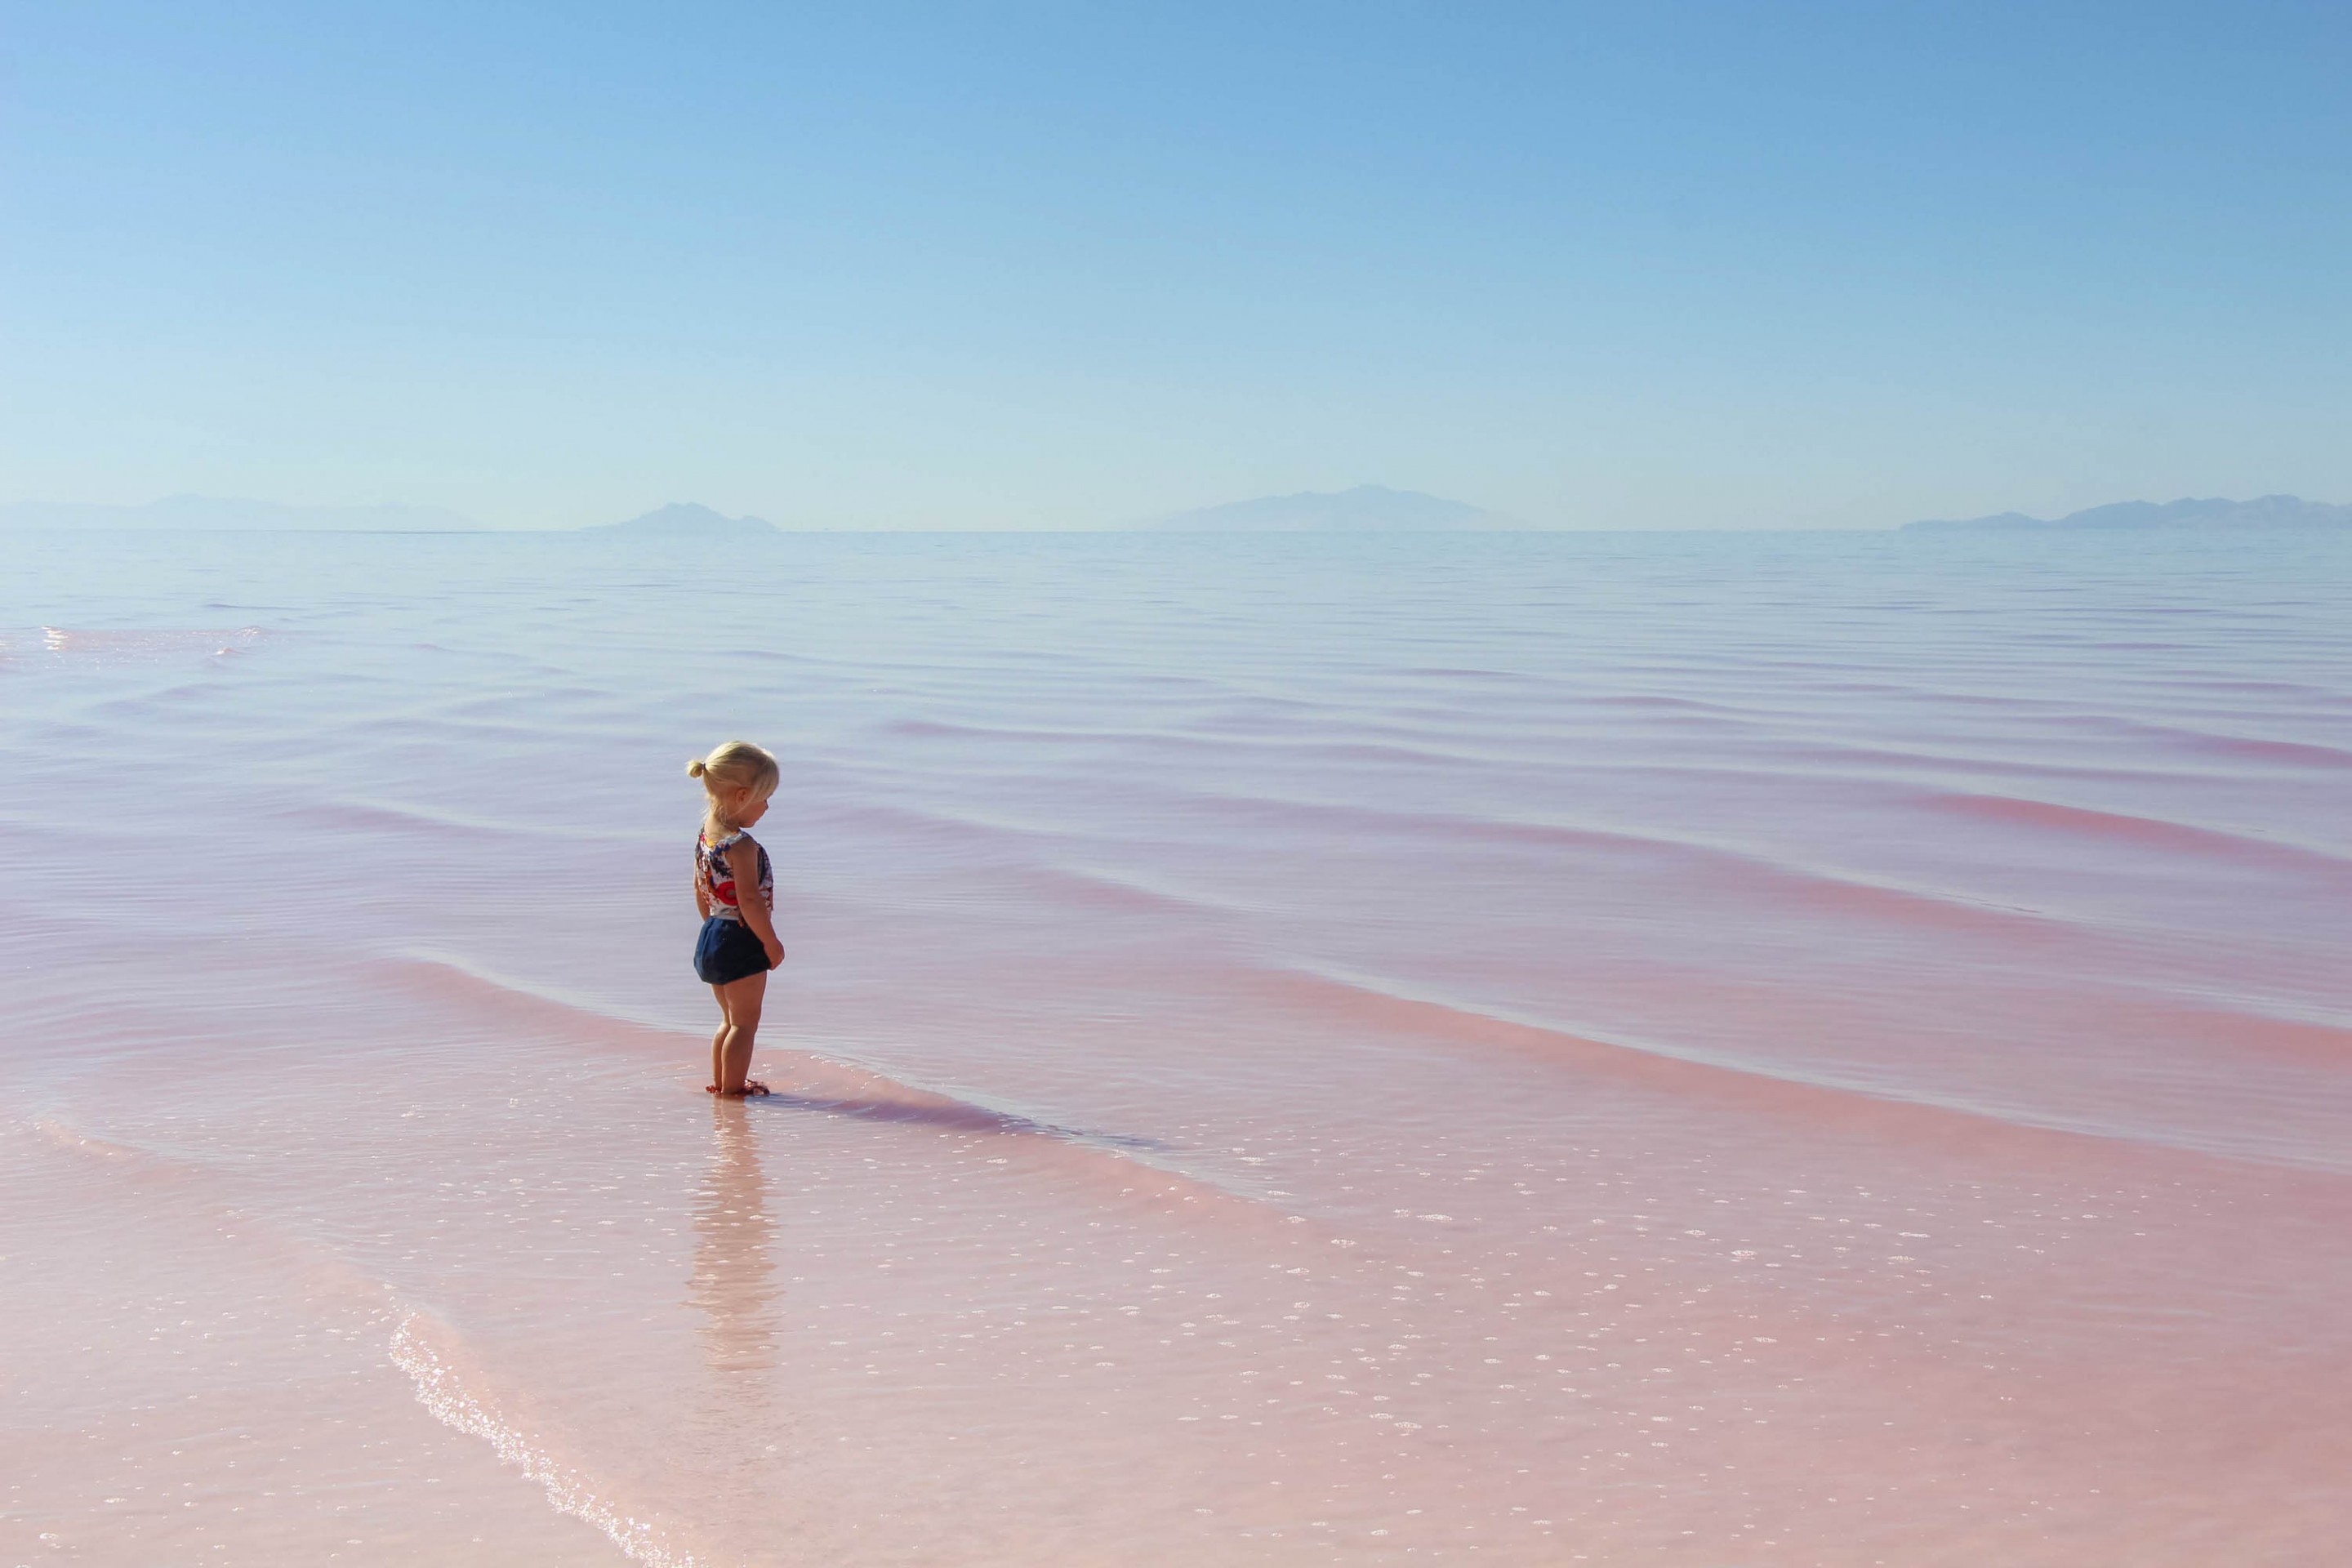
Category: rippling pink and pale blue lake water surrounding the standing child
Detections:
[{"x1": 0, "y1": 536, "x2": 2352, "y2": 1568}]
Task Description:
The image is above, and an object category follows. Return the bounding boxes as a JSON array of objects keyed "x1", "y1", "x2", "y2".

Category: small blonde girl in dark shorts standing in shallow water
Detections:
[{"x1": 687, "y1": 741, "x2": 783, "y2": 1100}]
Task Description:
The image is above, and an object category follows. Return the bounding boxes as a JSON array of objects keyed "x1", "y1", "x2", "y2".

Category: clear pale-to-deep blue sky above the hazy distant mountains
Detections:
[{"x1": 0, "y1": 0, "x2": 2352, "y2": 527}]
